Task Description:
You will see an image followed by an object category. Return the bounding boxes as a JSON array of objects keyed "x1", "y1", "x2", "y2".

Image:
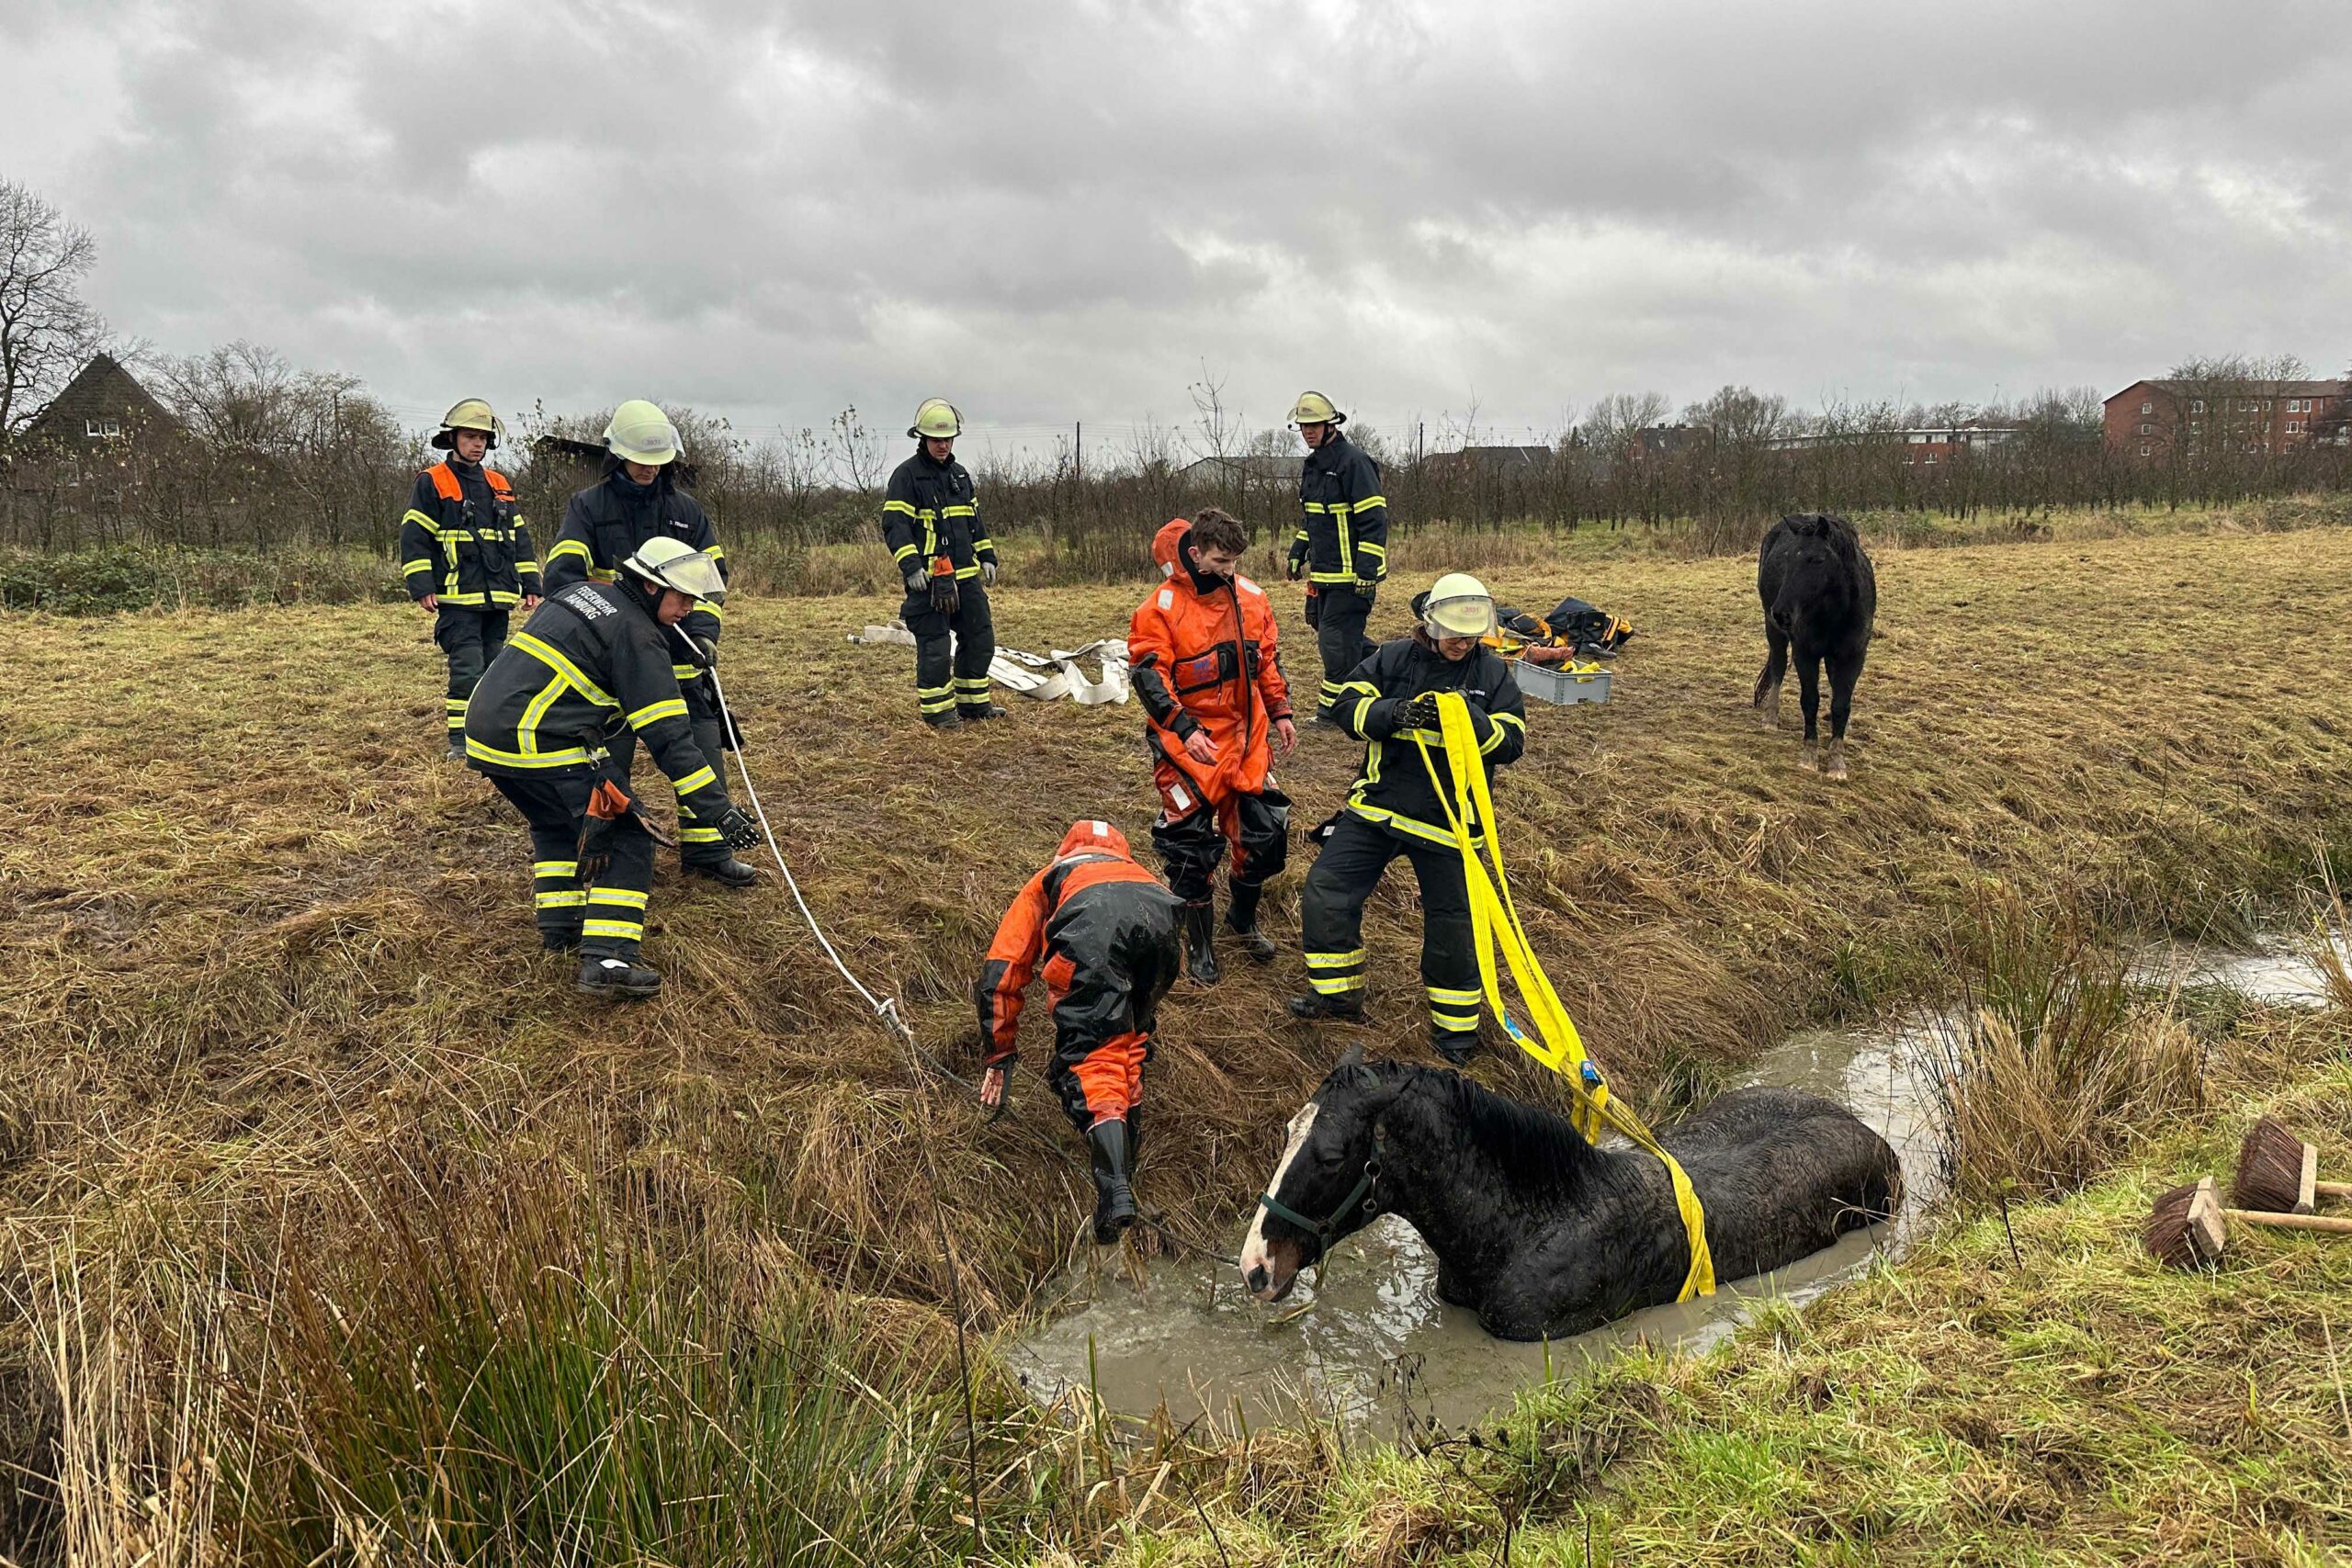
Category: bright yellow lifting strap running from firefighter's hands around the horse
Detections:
[{"x1": 1414, "y1": 691, "x2": 1714, "y2": 1300}]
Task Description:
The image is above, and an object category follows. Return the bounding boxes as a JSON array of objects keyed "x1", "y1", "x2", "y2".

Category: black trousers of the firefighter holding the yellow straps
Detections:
[{"x1": 1298, "y1": 811, "x2": 1482, "y2": 1034}]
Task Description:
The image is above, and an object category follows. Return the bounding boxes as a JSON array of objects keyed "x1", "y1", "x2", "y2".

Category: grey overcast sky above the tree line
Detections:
[{"x1": 0, "y1": 0, "x2": 2352, "y2": 445}]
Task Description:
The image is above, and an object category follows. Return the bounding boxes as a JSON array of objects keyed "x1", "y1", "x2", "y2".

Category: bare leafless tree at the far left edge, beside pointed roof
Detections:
[{"x1": 0, "y1": 181, "x2": 106, "y2": 437}]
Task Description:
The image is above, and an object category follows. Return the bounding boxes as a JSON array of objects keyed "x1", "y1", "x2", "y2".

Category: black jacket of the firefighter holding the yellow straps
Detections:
[{"x1": 1331, "y1": 632, "x2": 1526, "y2": 844}]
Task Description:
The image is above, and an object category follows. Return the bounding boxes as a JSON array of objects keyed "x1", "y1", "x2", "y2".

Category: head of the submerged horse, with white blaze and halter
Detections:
[{"x1": 1242, "y1": 1046, "x2": 1395, "y2": 1303}]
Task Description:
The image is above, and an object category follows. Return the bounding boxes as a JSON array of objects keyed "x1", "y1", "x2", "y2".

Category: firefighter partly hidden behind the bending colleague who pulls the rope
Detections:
[{"x1": 548, "y1": 398, "x2": 760, "y2": 888}]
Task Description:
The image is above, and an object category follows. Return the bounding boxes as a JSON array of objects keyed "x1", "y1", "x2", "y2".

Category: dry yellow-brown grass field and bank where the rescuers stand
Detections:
[{"x1": 0, "y1": 529, "x2": 2352, "y2": 1561}]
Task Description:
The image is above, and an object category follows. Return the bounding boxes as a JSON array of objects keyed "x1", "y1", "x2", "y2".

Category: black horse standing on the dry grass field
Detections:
[{"x1": 1755, "y1": 513, "x2": 1879, "y2": 778}]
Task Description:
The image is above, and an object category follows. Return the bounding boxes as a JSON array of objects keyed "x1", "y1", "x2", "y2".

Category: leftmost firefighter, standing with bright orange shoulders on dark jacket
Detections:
[{"x1": 400, "y1": 398, "x2": 538, "y2": 761}]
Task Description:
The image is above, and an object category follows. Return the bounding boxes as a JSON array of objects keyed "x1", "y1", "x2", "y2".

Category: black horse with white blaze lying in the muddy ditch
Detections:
[{"x1": 1242, "y1": 1046, "x2": 1903, "y2": 1340}]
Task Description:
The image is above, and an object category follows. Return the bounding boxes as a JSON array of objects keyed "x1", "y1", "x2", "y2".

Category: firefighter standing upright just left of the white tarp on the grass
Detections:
[{"x1": 882, "y1": 398, "x2": 1004, "y2": 728}]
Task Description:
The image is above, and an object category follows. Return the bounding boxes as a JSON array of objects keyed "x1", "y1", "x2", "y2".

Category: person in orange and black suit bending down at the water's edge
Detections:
[{"x1": 971, "y1": 823, "x2": 1179, "y2": 1244}]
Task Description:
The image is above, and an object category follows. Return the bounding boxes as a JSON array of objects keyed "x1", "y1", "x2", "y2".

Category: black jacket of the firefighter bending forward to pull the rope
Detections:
[{"x1": 466, "y1": 583, "x2": 727, "y2": 823}]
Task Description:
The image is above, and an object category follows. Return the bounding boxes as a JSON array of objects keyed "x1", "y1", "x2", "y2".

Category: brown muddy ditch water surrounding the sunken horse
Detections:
[{"x1": 1012, "y1": 1025, "x2": 1940, "y2": 1434}]
